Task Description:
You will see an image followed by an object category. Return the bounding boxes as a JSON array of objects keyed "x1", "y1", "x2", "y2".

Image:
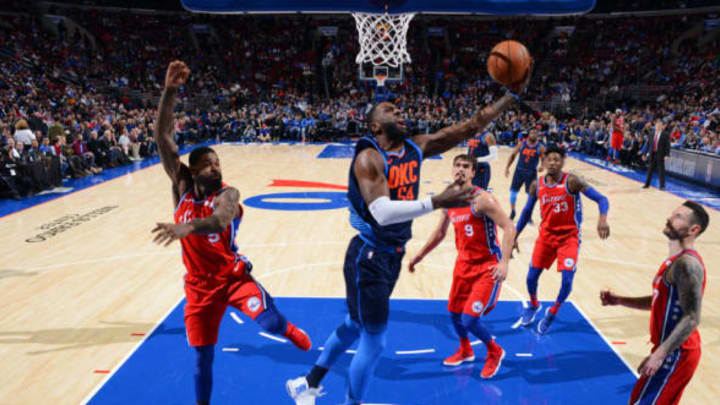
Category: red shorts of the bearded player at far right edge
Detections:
[{"x1": 630, "y1": 349, "x2": 700, "y2": 405}]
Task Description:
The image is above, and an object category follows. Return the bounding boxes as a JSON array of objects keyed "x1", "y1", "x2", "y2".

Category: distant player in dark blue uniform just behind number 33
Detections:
[{"x1": 505, "y1": 128, "x2": 545, "y2": 219}]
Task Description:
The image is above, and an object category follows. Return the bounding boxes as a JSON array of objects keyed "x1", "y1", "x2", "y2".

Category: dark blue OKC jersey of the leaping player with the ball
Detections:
[{"x1": 348, "y1": 137, "x2": 423, "y2": 248}]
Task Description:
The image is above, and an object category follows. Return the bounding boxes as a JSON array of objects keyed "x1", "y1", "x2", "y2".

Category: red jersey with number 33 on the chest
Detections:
[{"x1": 537, "y1": 173, "x2": 582, "y2": 237}]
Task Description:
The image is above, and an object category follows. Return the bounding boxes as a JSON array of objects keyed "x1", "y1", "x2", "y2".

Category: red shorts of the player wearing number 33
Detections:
[{"x1": 530, "y1": 232, "x2": 580, "y2": 271}]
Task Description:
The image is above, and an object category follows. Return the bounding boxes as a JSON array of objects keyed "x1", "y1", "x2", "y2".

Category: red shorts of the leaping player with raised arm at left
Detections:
[{"x1": 185, "y1": 273, "x2": 272, "y2": 346}]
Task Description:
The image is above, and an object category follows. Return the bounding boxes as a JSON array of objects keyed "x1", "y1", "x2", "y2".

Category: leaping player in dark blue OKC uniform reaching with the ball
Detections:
[{"x1": 286, "y1": 74, "x2": 530, "y2": 405}]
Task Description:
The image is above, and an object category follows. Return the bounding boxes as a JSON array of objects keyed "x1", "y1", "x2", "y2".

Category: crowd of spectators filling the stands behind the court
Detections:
[{"x1": 0, "y1": 8, "x2": 720, "y2": 198}]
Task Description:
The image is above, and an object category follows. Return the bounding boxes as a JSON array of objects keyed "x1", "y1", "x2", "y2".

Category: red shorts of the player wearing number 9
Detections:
[{"x1": 448, "y1": 261, "x2": 502, "y2": 316}]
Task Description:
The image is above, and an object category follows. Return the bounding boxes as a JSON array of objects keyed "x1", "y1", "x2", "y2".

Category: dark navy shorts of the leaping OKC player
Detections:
[{"x1": 343, "y1": 235, "x2": 405, "y2": 328}]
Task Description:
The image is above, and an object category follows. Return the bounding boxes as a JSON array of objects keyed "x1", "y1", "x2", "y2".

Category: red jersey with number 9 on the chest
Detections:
[{"x1": 447, "y1": 187, "x2": 501, "y2": 264}]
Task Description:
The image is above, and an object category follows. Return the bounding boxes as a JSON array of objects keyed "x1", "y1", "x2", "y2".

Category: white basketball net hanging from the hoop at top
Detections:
[{"x1": 352, "y1": 13, "x2": 415, "y2": 67}]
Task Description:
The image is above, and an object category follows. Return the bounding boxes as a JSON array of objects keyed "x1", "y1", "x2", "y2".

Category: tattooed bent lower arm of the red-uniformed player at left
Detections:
[{"x1": 152, "y1": 187, "x2": 240, "y2": 246}]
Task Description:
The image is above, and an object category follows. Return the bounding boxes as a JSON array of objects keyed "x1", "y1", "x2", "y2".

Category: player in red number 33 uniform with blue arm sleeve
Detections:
[{"x1": 515, "y1": 145, "x2": 610, "y2": 333}]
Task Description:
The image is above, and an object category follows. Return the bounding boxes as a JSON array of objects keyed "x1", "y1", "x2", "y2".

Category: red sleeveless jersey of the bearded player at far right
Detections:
[{"x1": 650, "y1": 249, "x2": 707, "y2": 349}]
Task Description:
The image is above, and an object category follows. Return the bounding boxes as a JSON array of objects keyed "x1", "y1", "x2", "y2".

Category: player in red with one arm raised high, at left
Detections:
[{"x1": 153, "y1": 61, "x2": 311, "y2": 404}]
